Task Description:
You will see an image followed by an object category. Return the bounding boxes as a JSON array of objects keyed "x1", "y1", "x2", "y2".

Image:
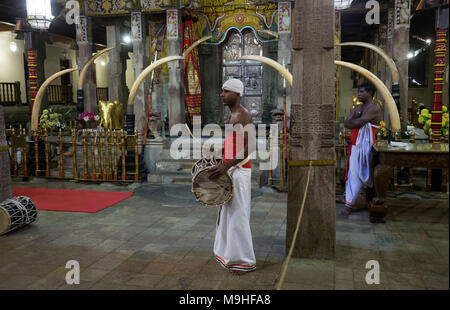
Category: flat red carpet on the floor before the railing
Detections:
[{"x1": 13, "y1": 187, "x2": 134, "y2": 213}]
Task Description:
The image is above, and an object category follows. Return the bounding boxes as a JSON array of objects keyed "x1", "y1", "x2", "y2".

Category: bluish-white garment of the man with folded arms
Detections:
[{"x1": 345, "y1": 123, "x2": 377, "y2": 206}]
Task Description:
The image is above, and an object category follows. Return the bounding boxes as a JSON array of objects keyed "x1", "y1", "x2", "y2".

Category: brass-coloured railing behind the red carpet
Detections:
[{"x1": 7, "y1": 126, "x2": 139, "y2": 182}]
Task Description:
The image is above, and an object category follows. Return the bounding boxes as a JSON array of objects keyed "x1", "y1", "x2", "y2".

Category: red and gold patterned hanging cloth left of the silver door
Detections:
[{"x1": 183, "y1": 20, "x2": 202, "y2": 124}]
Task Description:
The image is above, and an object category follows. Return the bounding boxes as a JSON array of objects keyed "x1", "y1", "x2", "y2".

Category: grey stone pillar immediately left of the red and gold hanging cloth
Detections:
[{"x1": 166, "y1": 10, "x2": 186, "y2": 131}]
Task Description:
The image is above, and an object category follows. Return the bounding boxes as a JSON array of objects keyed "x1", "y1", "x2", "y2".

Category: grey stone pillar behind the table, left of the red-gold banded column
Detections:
[{"x1": 392, "y1": 1, "x2": 410, "y2": 132}]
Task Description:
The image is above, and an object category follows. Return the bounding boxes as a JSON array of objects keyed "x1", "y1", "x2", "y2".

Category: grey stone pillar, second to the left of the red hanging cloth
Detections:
[{"x1": 131, "y1": 13, "x2": 151, "y2": 153}]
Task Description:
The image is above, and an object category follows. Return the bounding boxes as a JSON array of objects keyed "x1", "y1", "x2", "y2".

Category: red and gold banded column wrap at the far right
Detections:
[{"x1": 431, "y1": 30, "x2": 447, "y2": 143}]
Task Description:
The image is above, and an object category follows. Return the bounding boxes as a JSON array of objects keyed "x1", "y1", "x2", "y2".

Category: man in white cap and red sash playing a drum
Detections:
[{"x1": 210, "y1": 79, "x2": 256, "y2": 274}]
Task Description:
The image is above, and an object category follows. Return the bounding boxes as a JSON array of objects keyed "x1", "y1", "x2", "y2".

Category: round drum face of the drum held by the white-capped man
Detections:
[{"x1": 192, "y1": 168, "x2": 233, "y2": 207}]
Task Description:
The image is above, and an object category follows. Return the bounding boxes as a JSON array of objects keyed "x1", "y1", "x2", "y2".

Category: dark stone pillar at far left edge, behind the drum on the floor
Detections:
[{"x1": 0, "y1": 105, "x2": 13, "y2": 202}]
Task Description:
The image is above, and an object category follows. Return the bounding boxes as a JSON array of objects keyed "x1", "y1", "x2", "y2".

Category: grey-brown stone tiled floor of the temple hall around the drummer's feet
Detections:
[{"x1": 0, "y1": 180, "x2": 449, "y2": 290}]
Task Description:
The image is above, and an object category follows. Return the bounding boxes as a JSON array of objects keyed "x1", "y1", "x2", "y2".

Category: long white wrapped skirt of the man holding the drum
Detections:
[{"x1": 214, "y1": 167, "x2": 256, "y2": 271}]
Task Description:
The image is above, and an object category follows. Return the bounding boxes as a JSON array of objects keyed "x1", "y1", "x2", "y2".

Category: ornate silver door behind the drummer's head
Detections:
[{"x1": 222, "y1": 29, "x2": 263, "y2": 123}]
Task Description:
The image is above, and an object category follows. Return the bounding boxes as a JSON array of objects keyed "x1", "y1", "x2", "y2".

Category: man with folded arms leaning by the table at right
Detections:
[{"x1": 338, "y1": 83, "x2": 381, "y2": 215}]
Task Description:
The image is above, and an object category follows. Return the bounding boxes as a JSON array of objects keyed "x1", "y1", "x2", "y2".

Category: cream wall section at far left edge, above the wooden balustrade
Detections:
[{"x1": 0, "y1": 31, "x2": 27, "y2": 103}]
